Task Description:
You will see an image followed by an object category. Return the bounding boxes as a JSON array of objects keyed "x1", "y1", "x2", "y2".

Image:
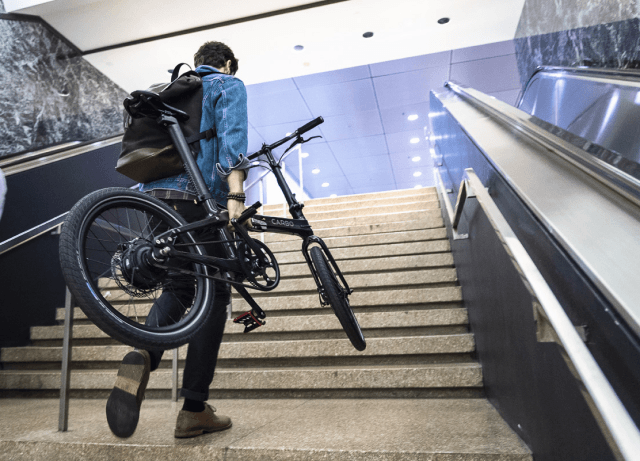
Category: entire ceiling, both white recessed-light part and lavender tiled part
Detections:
[{"x1": 4, "y1": 0, "x2": 524, "y2": 197}]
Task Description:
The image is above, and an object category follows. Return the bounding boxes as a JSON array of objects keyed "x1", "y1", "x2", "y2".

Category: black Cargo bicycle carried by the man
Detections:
[{"x1": 60, "y1": 91, "x2": 366, "y2": 351}]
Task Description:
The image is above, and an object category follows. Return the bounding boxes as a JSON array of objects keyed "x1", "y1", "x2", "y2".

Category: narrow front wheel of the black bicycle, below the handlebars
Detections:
[{"x1": 309, "y1": 247, "x2": 367, "y2": 351}]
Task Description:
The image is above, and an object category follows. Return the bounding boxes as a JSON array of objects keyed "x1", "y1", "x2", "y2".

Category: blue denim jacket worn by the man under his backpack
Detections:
[{"x1": 140, "y1": 66, "x2": 250, "y2": 206}]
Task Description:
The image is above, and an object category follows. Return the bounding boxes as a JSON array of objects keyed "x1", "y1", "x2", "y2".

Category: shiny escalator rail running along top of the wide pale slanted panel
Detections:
[{"x1": 445, "y1": 81, "x2": 640, "y2": 206}]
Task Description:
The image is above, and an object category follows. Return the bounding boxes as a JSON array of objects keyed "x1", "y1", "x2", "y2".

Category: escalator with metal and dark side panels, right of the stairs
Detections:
[{"x1": 429, "y1": 68, "x2": 640, "y2": 460}]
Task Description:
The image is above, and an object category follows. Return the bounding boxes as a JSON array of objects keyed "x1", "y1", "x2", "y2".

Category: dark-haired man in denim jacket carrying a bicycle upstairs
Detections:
[{"x1": 106, "y1": 42, "x2": 249, "y2": 437}]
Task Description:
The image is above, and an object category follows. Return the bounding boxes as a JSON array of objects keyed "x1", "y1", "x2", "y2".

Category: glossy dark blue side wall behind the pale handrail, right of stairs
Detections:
[{"x1": 430, "y1": 94, "x2": 640, "y2": 459}]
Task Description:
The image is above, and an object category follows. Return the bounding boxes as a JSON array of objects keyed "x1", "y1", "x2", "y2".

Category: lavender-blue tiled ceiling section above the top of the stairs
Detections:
[{"x1": 242, "y1": 40, "x2": 520, "y2": 198}]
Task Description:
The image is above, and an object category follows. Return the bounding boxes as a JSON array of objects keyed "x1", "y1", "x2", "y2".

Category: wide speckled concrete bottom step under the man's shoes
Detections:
[{"x1": 0, "y1": 398, "x2": 533, "y2": 461}]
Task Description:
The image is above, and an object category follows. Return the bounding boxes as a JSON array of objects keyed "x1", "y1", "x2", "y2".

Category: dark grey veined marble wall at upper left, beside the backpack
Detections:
[{"x1": 0, "y1": 2, "x2": 127, "y2": 158}]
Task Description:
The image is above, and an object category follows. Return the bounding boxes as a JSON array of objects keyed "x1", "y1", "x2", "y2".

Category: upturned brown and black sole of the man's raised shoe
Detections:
[{"x1": 106, "y1": 351, "x2": 149, "y2": 438}]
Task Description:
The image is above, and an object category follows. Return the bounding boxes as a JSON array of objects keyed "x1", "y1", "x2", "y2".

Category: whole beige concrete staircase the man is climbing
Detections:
[{"x1": 0, "y1": 189, "x2": 532, "y2": 460}]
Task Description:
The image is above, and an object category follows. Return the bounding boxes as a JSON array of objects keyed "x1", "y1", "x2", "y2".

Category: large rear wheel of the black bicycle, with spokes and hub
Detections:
[{"x1": 60, "y1": 188, "x2": 214, "y2": 349}]
